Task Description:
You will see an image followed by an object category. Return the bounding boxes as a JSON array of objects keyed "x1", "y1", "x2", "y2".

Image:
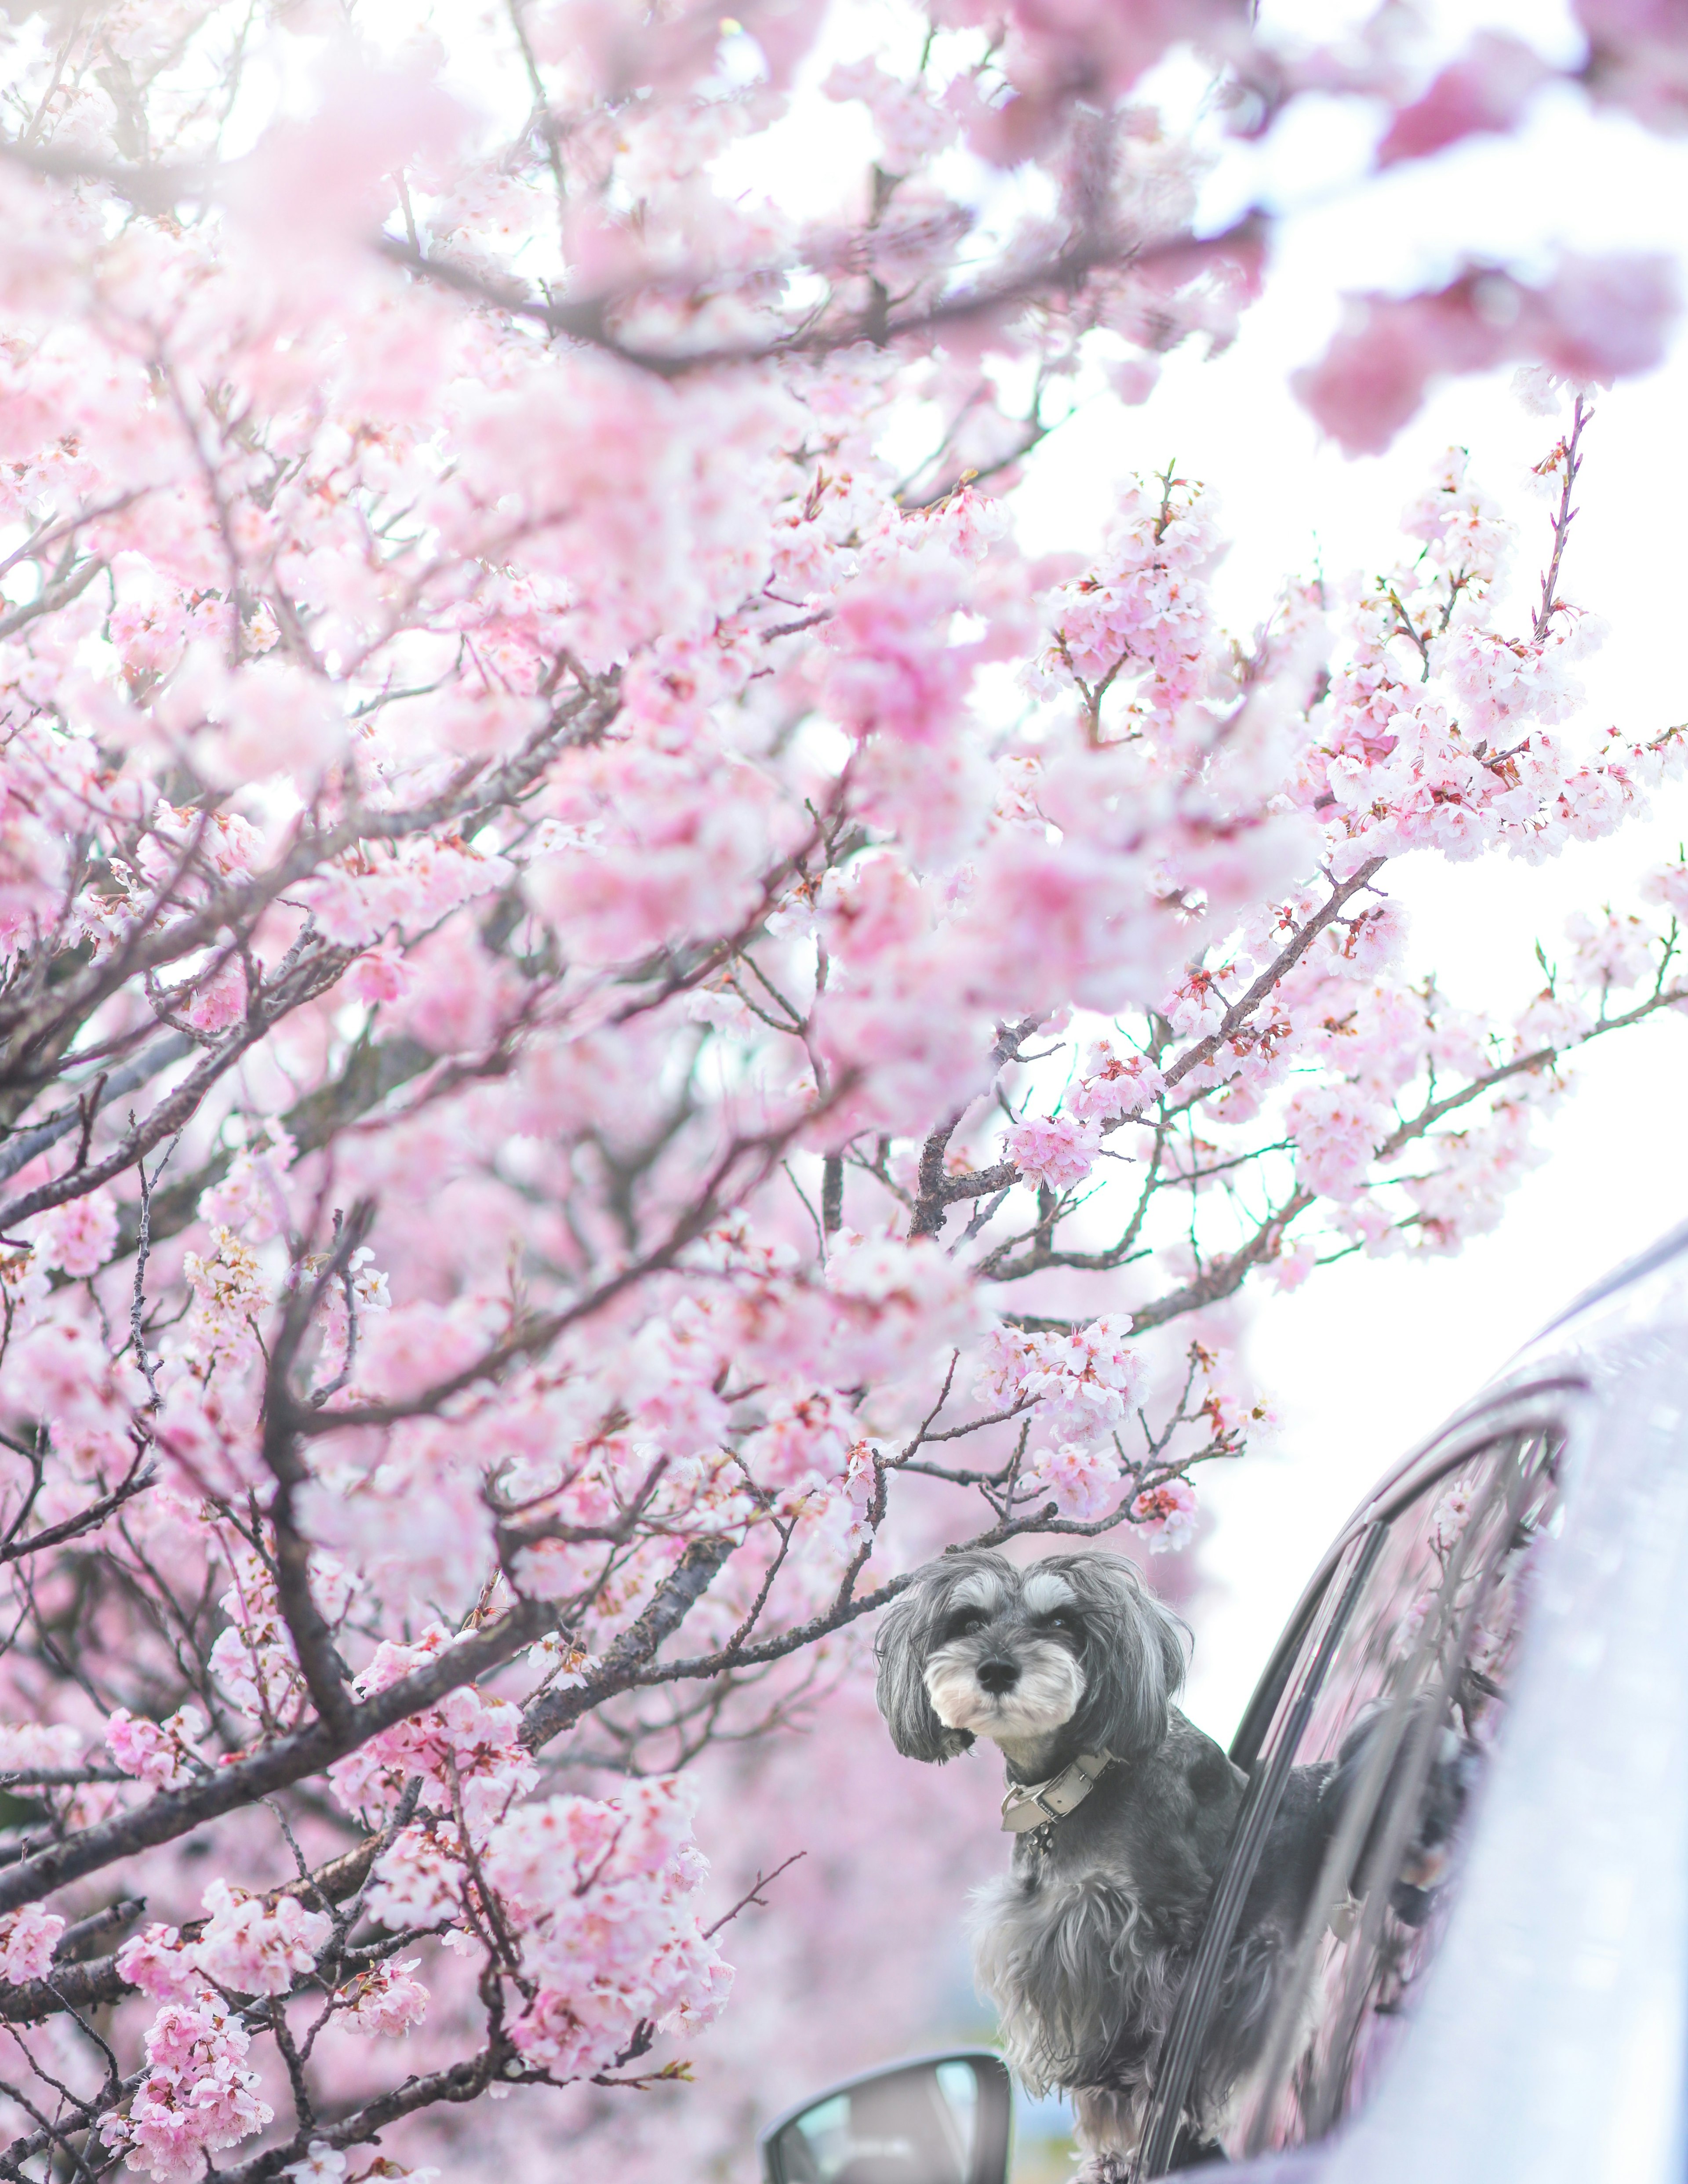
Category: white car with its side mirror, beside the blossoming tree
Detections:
[{"x1": 760, "y1": 1225, "x2": 1688, "y2": 2184}]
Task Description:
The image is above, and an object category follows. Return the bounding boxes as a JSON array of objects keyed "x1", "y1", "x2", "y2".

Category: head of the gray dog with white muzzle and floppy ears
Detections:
[{"x1": 876, "y1": 1553, "x2": 1183, "y2": 1760}]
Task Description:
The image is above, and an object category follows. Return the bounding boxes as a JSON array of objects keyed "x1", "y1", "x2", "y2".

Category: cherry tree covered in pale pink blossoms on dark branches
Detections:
[{"x1": 0, "y1": 13, "x2": 1688, "y2": 2184}]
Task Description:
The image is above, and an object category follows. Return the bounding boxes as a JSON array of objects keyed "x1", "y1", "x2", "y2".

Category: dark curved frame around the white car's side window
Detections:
[{"x1": 1131, "y1": 1374, "x2": 1587, "y2": 2184}]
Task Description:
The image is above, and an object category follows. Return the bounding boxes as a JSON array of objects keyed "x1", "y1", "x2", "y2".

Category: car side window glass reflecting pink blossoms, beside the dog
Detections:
[{"x1": 1142, "y1": 1433, "x2": 1559, "y2": 2175}]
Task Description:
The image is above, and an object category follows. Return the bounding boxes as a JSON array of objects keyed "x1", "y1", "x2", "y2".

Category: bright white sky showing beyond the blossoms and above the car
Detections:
[{"x1": 1000, "y1": 30, "x2": 1688, "y2": 1736}]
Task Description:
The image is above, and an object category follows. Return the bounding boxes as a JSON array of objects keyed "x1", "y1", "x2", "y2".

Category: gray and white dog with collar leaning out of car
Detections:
[{"x1": 876, "y1": 1553, "x2": 1328, "y2": 2184}]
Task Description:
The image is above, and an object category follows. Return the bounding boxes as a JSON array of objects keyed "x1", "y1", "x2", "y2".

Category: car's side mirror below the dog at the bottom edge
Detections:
[{"x1": 760, "y1": 2049, "x2": 1013, "y2": 2184}]
